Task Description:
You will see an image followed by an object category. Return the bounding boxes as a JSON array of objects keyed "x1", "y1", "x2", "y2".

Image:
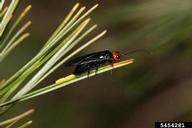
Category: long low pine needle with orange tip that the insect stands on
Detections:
[{"x1": 0, "y1": 59, "x2": 134, "y2": 107}]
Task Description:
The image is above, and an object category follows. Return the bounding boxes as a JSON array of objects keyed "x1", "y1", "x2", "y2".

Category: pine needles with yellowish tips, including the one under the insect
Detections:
[{"x1": 0, "y1": 0, "x2": 133, "y2": 125}]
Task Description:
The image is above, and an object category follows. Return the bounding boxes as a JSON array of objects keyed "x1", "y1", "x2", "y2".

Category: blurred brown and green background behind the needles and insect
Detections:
[{"x1": 0, "y1": 0, "x2": 192, "y2": 128}]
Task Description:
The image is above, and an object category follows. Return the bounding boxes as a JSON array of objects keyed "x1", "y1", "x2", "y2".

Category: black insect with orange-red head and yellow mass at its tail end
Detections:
[{"x1": 56, "y1": 49, "x2": 150, "y2": 83}]
